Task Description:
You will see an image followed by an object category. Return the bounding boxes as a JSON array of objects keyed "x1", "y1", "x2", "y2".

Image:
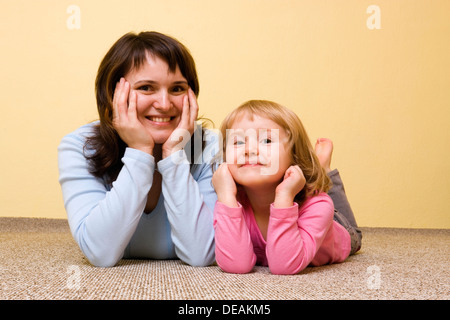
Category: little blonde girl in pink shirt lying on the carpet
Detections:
[{"x1": 212, "y1": 100, "x2": 361, "y2": 274}]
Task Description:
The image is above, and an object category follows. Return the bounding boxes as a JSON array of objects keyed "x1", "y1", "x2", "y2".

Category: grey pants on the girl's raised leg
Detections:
[{"x1": 328, "y1": 169, "x2": 362, "y2": 254}]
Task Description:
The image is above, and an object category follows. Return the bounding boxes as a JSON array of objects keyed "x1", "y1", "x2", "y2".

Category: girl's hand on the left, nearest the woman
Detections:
[{"x1": 212, "y1": 163, "x2": 238, "y2": 207}]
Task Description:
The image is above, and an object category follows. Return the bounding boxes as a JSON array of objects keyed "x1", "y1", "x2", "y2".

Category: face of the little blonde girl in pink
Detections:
[{"x1": 225, "y1": 114, "x2": 292, "y2": 187}]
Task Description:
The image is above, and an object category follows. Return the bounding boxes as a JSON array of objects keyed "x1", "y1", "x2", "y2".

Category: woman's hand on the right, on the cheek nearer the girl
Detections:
[{"x1": 162, "y1": 88, "x2": 198, "y2": 158}]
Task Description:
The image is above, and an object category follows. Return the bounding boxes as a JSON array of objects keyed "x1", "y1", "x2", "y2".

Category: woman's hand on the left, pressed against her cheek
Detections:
[{"x1": 112, "y1": 78, "x2": 155, "y2": 154}]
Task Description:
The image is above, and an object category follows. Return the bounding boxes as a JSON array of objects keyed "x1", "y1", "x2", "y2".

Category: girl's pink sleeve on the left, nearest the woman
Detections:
[{"x1": 214, "y1": 201, "x2": 256, "y2": 273}]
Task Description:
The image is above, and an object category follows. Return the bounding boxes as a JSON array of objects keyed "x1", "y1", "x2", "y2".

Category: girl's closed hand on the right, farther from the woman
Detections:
[{"x1": 274, "y1": 166, "x2": 306, "y2": 208}]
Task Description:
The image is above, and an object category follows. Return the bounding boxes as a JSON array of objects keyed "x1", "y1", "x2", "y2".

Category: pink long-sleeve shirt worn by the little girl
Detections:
[{"x1": 214, "y1": 193, "x2": 351, "y2": 274}]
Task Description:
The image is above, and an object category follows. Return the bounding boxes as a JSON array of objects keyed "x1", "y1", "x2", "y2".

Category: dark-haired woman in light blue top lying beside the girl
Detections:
[{"x1": 58, "y1": 32, "x2": 218, "y2": 267}]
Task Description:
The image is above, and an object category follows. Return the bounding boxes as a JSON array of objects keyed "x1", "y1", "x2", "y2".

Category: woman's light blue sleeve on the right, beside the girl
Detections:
[{"x1": 158, "y1": 131, "x2": 217, "y2": 266}]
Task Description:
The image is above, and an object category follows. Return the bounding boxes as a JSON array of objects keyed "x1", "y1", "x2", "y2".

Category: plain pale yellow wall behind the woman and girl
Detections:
[{"x1": 0, "y1": 0, "x2": 450, "y2": 228}]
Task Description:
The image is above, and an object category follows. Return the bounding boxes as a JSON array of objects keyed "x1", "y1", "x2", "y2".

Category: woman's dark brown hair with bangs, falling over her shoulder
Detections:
[{"x1": 85, "y1": 32, "x2": 200, "y2": 184}]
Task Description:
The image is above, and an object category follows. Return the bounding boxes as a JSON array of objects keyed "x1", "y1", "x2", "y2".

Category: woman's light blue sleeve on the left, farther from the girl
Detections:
[{"x1": 58, "y1": 134, "x2": 155, "y2": 267}]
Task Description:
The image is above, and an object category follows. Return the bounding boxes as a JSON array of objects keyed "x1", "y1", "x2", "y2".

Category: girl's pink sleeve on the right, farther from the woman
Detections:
[{"x1": 266, "y1": 194, "x2": 334, "y2": 274}]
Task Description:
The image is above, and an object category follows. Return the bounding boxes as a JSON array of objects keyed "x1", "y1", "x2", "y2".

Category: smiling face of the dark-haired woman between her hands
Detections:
[{"x1": 125, "y1": 54, "x2": 189, "y2": 144}]
